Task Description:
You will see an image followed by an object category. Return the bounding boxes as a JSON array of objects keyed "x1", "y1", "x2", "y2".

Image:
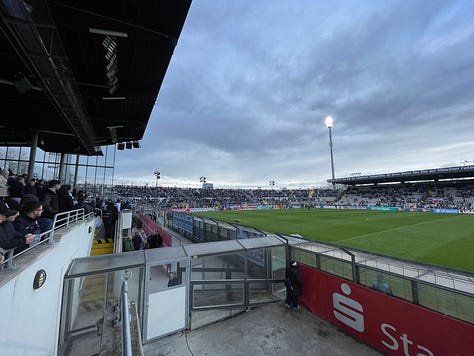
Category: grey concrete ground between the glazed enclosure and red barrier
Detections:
[{"x1": 144, "y1": 302, "x2": 382, "y2": 356}]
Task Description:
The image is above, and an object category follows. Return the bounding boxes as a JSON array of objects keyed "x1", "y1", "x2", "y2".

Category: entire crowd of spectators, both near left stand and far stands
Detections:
[{"x1": 0, "y1": 166, "x2": 474, "y2": 262}]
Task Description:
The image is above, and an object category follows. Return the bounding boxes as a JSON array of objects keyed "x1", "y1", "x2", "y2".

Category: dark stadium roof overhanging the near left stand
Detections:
[{"x1": 0, "y1": 0, "x2": 191, "y2": 155}]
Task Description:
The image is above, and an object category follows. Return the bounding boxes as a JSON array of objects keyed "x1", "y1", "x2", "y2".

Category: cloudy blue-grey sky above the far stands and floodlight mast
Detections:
[{"x1": 115, "y1": 0, "x2": 474, "y2": 187}]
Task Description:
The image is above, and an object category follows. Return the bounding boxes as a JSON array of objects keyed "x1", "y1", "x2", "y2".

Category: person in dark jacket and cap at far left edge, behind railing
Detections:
[{"x1": 0, "y1": 201, "x2": 34, "y2": 250}]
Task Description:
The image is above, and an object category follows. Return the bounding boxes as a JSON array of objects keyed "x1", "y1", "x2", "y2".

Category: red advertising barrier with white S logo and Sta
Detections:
[{"x1": 299, "y1": 265, "x2": 474, "y2": 356}]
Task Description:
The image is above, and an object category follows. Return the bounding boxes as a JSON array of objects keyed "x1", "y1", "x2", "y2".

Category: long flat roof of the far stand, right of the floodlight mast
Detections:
[{"x1": 327, "y1": 165, "x2": 474, "y2": 185}]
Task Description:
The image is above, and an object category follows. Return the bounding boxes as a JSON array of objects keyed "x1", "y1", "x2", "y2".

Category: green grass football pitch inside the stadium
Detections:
[{"x1": 196, "y1": 209, "x2": 474, "y2": 272}]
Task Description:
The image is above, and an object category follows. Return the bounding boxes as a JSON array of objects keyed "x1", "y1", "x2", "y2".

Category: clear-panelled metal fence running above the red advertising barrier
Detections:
[{"x1": 285, "y1": 235, "x2": 474, "y2": 323}]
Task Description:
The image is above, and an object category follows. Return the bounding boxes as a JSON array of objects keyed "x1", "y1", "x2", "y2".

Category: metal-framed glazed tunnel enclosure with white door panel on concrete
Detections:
[{"x1": 58, "y1": 237, "x2": 287, "y2": 355}]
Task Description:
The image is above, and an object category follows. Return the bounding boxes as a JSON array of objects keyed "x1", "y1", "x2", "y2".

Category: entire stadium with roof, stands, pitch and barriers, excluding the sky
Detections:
[{"x1": 0, "y1": 0, "x2": 474, "y2": 356}]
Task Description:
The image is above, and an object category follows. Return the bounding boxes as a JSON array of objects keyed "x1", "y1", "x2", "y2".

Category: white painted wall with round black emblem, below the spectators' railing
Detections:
[{"x1": 0, "y1": 219, "x2": 95, "y2": 356}]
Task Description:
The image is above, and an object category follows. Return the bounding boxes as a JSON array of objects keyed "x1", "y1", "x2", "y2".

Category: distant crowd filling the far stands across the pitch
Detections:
[{"x1": 114, "y1": 180, "x2": 474, "y2": 211}]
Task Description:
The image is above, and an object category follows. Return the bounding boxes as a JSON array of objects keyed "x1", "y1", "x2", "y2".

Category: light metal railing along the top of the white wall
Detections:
[{"x1": 0, "y1": 208, "x2": 94, "y2": 270}]
